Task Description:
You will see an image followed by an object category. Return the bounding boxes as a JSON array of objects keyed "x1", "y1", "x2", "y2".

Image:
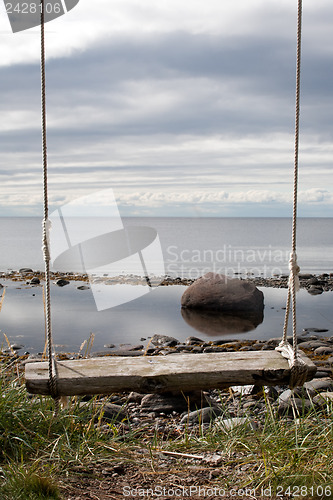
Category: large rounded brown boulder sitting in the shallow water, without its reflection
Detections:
[{"x1": 181, "y1": 272, "x2": 264, "y2": 314}]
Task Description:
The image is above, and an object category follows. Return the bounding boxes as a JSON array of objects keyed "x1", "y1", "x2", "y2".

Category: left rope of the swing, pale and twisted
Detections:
[{"x1": 40, "y1": 0, "x2": 60, "y2": 415}]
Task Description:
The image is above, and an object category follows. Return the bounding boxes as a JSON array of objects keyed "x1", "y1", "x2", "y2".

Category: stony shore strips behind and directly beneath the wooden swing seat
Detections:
[{"x1": 0, "y1": 268, "x2": 333, "y2": 430}]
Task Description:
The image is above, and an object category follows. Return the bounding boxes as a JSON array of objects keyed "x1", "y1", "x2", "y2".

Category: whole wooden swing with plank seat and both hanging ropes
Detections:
[{"x1": 25, "y1": 0, "x2": 316, "y2": 401}]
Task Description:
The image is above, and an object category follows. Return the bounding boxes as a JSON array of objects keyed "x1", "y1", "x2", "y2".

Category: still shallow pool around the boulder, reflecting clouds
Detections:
[{"x1": 0, "y1": 281, "x2": 333, "y2": 352}]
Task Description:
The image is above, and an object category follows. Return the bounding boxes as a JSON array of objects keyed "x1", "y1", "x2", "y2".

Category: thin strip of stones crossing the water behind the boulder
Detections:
[{"x1": 0, "y1": 268, "x2": 333, "y2": 295}]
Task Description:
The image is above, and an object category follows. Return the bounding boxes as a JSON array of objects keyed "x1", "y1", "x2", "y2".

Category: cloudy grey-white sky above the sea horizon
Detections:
[{"x1": 0, "y1": 0, "x2": 333, "y2": 217}]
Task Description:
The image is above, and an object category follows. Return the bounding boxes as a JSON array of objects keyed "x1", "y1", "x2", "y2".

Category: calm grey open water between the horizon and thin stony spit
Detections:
[{"x1": 0, "y1": 217, "x2": 333, "y2": 278}]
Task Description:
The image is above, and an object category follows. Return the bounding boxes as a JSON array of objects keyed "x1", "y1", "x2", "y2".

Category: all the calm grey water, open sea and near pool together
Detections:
[{"x1": 0, "y1": 217, "x2": 333, "y2": 353}]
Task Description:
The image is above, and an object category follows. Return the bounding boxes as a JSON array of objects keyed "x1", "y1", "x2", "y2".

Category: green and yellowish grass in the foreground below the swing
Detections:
[{"x1": 0, "y1": 354, "x2": 333, "y2": 500}]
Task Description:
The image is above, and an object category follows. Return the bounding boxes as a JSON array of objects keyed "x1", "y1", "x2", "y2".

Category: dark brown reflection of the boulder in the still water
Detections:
[{"x1": 181, "y1": 308, "x2": 264, "y2": 335}]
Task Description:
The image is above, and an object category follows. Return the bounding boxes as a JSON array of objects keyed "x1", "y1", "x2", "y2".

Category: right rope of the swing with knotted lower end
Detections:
[{"x1": 276, "y1": 0, "x2": 308, "y2": 389}]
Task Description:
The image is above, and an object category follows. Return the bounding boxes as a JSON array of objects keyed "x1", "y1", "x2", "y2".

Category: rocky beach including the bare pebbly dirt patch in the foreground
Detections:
[{"x1": 0, "y1": 269, "x2": 333, "y2": 500}]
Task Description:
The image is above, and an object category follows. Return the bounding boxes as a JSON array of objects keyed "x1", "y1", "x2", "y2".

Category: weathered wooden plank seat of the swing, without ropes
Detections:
[{"x1": 25, "y1": 351, "x2": 316, "y2": 396}]
